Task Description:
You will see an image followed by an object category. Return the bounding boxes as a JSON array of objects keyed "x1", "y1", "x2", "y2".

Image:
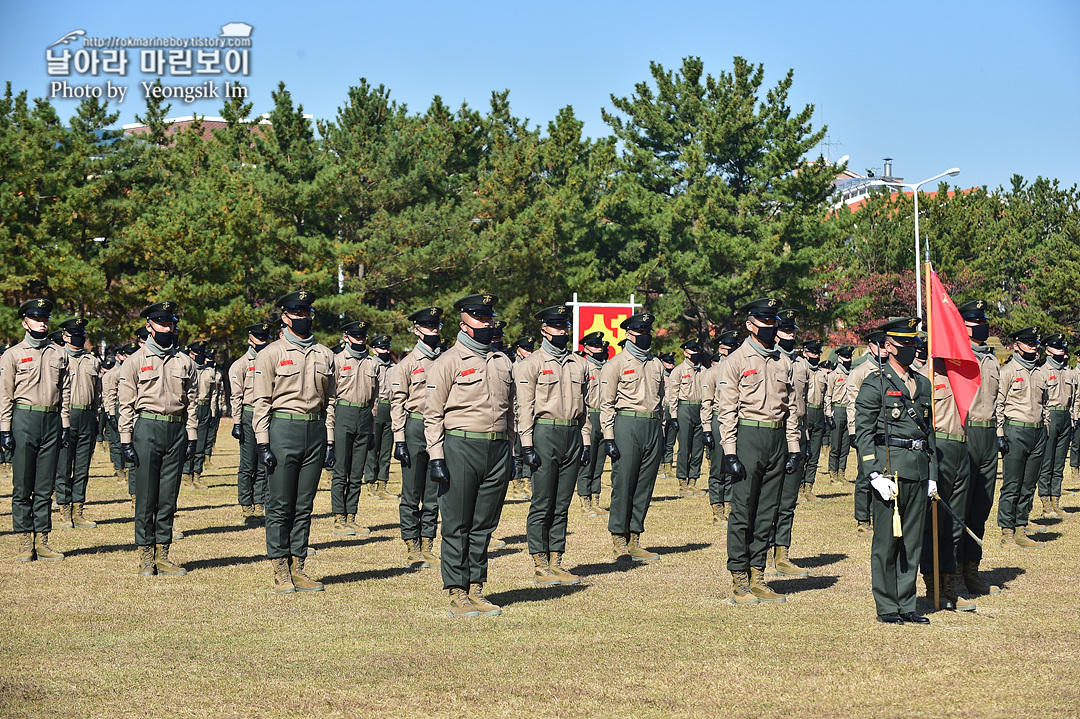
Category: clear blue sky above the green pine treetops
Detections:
[{"x1": 0, "y1": 0, "x2": 1080, "y2": 188}]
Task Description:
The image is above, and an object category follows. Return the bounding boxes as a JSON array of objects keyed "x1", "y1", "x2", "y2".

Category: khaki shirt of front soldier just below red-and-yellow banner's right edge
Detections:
[{"x1": 600, "y1": 350, "x2": 665, "y2": 439}]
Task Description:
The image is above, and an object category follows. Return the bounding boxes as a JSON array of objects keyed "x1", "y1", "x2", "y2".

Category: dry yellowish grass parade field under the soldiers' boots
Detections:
[{"x1": 0, "y1": 420, "x2": 1080, "y2": 719}]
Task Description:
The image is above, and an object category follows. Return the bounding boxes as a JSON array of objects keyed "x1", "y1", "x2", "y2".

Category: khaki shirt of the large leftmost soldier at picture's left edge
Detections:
[{"x1": 0, "y1": 340, "x2": 71, "y2": 432}]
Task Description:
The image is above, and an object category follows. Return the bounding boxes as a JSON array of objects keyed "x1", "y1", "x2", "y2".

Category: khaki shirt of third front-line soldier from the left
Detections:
[{"x1": 252, "y1": 337, "x2": 335, "y2": 445}]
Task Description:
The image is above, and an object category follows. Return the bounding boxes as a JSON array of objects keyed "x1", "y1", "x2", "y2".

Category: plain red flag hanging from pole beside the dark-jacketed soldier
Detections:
[{"x1": 928, "y1": 266, "x2": 982, "y2": 423}]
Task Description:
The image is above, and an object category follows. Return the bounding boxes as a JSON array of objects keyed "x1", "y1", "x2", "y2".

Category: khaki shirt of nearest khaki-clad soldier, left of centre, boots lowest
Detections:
[{"x1": 423, "y1": 341, "x2": 516, "y2": 459}]
